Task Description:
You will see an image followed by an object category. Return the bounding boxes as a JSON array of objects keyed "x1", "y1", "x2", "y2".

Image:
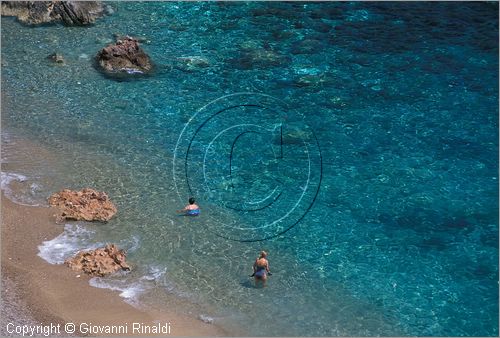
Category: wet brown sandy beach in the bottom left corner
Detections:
[{"x1": 1, "y1": 192, "x2": 229, "y2": 336}]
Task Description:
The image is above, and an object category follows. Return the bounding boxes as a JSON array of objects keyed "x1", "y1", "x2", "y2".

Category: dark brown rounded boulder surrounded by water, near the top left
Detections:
[{"x1": 96, "y1": 36, "x2": 153, "y2": 76}]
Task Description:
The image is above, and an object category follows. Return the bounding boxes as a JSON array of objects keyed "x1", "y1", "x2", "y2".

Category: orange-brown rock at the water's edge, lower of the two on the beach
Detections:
[{"x1": 64, "y1": 244, "x2": 130, "y2": 277}]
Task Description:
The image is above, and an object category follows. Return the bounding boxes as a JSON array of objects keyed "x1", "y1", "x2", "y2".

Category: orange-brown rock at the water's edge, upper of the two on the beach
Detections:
[{"x1": 49, "y1": 189, "x2": 117, "y2": 222}]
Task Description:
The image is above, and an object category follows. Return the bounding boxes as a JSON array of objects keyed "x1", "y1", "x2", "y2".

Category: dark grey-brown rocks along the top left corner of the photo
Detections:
[{"x1": 2, "y1": 1, "x2": 105, "y2": 26}]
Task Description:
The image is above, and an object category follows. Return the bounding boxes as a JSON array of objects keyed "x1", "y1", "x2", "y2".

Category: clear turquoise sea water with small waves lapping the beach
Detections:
[{"x1": 2, "y1": 2, "x2": 498, "y2": 336}]
